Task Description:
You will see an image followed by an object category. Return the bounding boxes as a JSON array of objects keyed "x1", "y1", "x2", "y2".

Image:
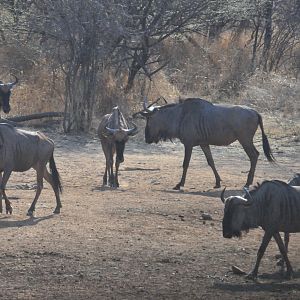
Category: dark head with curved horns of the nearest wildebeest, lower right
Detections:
[{"x1": 221, "y1": 188, "x2": 252, "y2": 238}]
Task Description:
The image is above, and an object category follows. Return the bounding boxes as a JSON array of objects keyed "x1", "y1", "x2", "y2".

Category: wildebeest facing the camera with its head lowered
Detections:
[{"x1": 98, "y1": 106, "x2": 137, "y2": 187}]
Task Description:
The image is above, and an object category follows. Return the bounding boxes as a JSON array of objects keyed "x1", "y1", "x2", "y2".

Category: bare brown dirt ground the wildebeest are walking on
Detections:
[{"x1": 0, "y1": 126, "x2": 300, "y2": 299}]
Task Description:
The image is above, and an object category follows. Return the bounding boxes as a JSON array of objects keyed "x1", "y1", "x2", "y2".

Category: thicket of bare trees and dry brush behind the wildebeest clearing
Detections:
[{"x1": 0, "y1": 0, "x2": 300, "y2": 139}]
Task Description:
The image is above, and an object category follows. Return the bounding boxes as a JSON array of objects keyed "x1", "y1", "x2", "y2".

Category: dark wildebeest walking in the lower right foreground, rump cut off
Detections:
[{"x1": 221, "y1": 180, "x2": 300, "y2": 279}]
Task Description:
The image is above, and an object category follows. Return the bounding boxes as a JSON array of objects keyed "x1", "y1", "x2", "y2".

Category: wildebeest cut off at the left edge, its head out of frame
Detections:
[{"x1": 0, "y1": 123, "x2": 62, "y2": 216}]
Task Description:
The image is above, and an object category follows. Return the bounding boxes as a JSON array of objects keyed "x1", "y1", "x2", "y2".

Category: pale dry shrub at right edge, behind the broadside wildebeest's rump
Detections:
[{"x1": 236, "y1": 70, "x2": 300, "y2": 138}]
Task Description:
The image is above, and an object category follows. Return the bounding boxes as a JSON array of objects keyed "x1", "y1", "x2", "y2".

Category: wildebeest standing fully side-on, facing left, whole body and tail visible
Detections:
[{"x1": 140, "y1": 98, "x2": 274, "y2": 190}]
